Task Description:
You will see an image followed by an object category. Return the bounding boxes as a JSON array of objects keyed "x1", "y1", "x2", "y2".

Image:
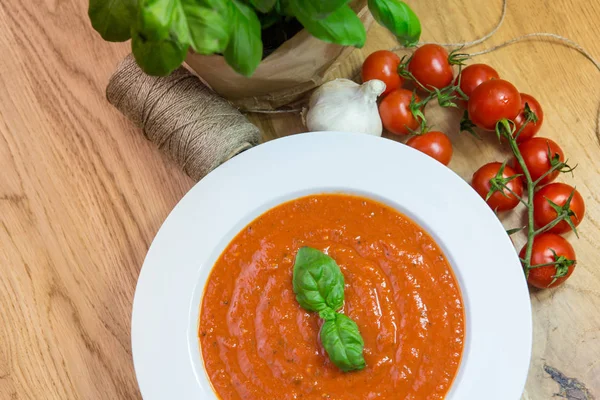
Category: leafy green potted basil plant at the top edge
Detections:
[{"x1": 88, "y1": 0, "x2": 421, "y2": 76}]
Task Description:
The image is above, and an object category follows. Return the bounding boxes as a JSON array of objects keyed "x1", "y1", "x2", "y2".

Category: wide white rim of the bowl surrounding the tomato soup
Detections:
[{"x1": 131, "y1": 132, "x2": 532, "y2": 400}]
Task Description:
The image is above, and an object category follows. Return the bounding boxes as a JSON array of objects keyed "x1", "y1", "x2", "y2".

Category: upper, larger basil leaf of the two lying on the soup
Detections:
[{"x1": 292, "y1": 247, "x2": 344, "y2": 312}]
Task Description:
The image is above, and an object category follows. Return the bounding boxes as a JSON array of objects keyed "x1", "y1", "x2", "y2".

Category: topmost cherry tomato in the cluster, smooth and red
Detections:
[{"x1": 408, "y1": 44, "x2": 454, "y2": 89}]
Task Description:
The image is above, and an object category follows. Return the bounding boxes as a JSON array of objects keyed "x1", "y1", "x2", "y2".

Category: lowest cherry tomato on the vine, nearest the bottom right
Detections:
[{"x1": 519, "y1": 233, "x2": 576, "y2": 289}]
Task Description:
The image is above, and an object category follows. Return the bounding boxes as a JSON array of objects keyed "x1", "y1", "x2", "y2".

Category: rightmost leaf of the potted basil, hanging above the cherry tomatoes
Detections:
[{"x1": 368, "y1": 0, "x2": 421, "y2": 47}]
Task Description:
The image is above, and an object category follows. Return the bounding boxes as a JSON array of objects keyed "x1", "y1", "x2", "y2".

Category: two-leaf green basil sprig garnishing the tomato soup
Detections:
[{"x1": 292, "y1": 247, "x2": 366, "y2": 372}]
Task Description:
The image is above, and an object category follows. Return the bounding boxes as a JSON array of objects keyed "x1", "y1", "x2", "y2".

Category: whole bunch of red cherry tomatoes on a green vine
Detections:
[{"x1": 362, "y1": 44, "x2": 585, "y2": 288}]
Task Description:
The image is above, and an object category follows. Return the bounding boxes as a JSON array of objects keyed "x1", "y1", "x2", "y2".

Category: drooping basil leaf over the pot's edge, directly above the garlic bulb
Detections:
[{"x1": 290, "y1": 0, "x2": 367, "y2": 47}]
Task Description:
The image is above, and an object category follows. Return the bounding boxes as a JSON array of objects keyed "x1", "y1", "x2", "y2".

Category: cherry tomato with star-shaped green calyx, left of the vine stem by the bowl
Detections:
[{"x1": 471, "y1": 162, "x2": 523, "y2": 211}]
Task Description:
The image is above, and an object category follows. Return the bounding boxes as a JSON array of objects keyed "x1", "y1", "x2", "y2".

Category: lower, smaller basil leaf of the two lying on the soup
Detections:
[{"x1": 321, "y1": 314, "x2": 366, "y2": 372}]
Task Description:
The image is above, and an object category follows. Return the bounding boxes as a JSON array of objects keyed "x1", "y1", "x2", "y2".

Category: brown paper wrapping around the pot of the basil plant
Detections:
[{"x1": 186, "y1": 0, "x2": 373, "y2": 110}]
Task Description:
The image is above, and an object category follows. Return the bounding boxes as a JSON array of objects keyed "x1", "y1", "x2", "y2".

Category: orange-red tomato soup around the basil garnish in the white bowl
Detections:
[{"x1": 198, "y1": 194, "x2": 465, "y2": 400}]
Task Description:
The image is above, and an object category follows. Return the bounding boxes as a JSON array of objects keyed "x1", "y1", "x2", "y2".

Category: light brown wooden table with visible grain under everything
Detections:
[{"x1": 0, "y1": 0, "x2": 600, "y2": 400}]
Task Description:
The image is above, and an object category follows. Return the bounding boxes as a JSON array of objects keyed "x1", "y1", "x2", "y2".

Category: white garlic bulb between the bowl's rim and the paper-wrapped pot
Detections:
[{"x1": 306, "y1": 79, "x2": 385, "y2": 136}]
